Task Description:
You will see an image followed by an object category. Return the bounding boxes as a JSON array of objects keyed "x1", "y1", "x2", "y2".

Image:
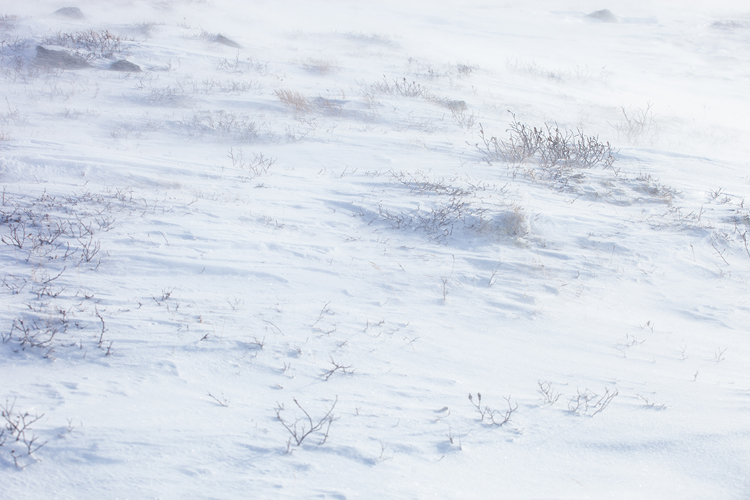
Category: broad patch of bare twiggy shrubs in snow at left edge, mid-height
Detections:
[{"x1": 0, "y1": 192, "x2": 121, "y2": 358}]
